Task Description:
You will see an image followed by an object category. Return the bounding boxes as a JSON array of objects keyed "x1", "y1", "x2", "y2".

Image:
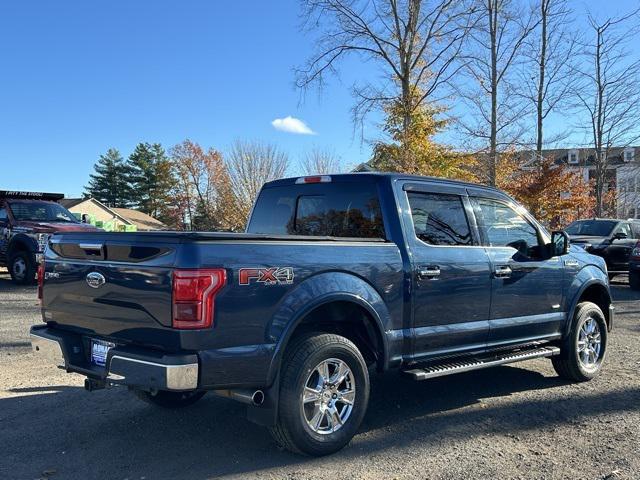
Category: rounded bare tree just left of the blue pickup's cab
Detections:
[{"x1": 226, "y1": 140, "x2": 289, "y2": 222}]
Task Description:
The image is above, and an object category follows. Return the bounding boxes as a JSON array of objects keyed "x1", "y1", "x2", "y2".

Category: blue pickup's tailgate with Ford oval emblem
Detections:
[{"x1": 42, "y1": 233, "x2": 180, "y2": 347}]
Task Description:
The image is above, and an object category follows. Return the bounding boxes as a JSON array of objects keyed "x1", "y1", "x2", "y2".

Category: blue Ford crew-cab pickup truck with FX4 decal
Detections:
[{"x1": 31, "y1": 173, "x2": 614, "y2": 455}]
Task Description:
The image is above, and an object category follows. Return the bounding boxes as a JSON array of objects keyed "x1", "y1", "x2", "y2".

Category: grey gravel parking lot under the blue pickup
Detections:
[{"x1": 0, "y1": 272, "x2": 640, "y2": 480}]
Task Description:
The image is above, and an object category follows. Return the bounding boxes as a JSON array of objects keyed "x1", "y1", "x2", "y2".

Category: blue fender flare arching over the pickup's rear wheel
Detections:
[{"x1": 268, "y1": 272, "x2": 391, "y2": 384}]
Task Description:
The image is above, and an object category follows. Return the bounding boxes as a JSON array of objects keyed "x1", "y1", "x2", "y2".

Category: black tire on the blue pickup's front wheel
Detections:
[{"x1": 551, "y1": 302, "x2": 607, "y2": 382}]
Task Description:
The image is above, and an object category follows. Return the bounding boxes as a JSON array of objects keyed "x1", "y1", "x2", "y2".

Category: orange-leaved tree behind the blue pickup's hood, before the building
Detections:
[{"x1": 498, "y1": 154, "x2": 595, "y2": 229}]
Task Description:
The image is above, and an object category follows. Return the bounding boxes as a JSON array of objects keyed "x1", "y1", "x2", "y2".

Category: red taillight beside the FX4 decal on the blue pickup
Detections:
[{"x1": 172, "y1": 268, "x2": 227, "y2": 329}]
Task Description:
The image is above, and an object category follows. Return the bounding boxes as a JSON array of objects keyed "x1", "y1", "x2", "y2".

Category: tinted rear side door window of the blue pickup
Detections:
[{"x1": 407, "y1": 192, "x2": 473, "y2": 246}]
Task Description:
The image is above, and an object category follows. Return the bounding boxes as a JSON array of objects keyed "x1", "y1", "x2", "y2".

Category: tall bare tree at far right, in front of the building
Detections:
[{"x1": 574, "y1": 9, "x2": 640, "y2": 215}]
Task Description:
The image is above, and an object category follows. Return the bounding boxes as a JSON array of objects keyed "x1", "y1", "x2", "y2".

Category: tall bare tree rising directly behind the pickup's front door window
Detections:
[{"x1": 460, "y1": 0, "x2": 538, "y2": 185}]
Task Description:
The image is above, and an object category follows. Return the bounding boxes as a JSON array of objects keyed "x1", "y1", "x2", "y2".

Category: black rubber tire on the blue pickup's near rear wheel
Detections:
[{"x1": 270, "y1": 333, "x2": 369, "y2": 456}]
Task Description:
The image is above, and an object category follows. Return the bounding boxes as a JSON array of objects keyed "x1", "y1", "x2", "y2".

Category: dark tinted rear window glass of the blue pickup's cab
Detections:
[{"x1": 247, "y1": 183, "x2": 384, "y2": 238}]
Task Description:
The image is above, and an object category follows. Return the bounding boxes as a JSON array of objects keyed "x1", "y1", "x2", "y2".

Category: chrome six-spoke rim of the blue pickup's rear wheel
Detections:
[{"x1": 301, "y1": 358, "x2": 356, "y2": 435}]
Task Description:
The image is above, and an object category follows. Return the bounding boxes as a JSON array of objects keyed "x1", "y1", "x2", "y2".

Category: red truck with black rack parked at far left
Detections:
[{"x1": 0, "y1": 190, "x2": 97, "y2": 285}]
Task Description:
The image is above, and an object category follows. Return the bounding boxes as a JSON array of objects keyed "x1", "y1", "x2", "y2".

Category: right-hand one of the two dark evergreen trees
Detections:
[{"x1": 127, "y1": 143, "x2": 176, "y2": 221}]
